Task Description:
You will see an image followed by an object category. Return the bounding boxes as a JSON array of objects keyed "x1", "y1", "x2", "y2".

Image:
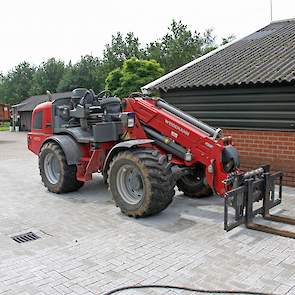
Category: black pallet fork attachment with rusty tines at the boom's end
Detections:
[{"x1": 224, "y1": 165, "x2": 295, "y2": 239}]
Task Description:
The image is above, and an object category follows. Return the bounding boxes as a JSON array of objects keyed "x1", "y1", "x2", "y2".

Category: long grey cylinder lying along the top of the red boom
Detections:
[{"x1": 156, "y1": 100, "x2": 221, "y2": 139}]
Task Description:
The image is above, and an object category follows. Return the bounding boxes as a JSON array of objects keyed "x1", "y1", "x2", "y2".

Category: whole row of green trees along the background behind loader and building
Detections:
[{"x1": 0, "y1": 20, "x2": 235, "y2": 104}]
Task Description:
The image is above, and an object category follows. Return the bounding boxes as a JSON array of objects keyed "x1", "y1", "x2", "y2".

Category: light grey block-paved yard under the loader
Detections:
[{"x1": 0, "y1": 132, "x2": 295, "y2": 295}]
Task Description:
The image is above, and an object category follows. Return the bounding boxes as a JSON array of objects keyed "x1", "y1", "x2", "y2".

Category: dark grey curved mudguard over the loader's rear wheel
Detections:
[{"x1": 43, "y1": 135, "x2": 82, "y2": 165}]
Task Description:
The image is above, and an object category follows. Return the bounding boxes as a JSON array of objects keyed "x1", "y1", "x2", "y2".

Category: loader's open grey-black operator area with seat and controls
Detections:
[{"x1": 52, "y1": 88, "x2": 130, "y2": 145}]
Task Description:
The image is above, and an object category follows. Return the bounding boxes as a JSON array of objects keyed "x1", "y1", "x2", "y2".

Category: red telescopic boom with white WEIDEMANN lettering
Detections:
[{"x1": 125, "y1": 98, "x2": 234, "y2": 196}]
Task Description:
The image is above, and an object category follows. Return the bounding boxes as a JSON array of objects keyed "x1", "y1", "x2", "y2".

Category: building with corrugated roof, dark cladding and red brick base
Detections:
[{"x1": 143, "y1": 19, "x2": 295, "y2": 186}]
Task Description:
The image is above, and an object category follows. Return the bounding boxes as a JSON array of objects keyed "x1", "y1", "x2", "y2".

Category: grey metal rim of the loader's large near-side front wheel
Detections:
[{"x1": 116, "y1": 164, "x2": 144, "y2": 205}]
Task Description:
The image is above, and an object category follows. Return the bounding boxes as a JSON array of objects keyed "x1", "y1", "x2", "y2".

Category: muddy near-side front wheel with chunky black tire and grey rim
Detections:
[{"x1": 108, "y1": 149, "x2": 175, "y2": 217}]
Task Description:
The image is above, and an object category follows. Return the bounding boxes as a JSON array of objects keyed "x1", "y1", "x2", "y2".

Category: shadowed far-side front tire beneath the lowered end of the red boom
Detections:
[{"x1": 177, "y1": 166, "x2": 212, "y2": 198}]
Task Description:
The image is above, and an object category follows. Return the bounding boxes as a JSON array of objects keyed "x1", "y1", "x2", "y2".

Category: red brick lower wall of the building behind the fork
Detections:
[{"x1": 223, "y1": 129, "x2": 295, "y2": 186}]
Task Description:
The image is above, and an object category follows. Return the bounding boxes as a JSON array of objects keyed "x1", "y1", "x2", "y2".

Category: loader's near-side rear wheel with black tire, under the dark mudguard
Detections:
[{"x1": 39, "y1": 142, "x2": 84, "y2": 194}]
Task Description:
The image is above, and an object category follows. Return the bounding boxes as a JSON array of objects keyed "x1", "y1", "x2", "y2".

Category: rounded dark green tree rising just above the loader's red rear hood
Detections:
[{"x1": 30, "y1": 58, "x2": 65, "y2": 95}]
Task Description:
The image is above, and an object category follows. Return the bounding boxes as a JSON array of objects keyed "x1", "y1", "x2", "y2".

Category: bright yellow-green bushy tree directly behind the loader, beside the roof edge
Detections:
[{"x1": 106, "y1": 57, "x2": 164, "y2": 97}]
